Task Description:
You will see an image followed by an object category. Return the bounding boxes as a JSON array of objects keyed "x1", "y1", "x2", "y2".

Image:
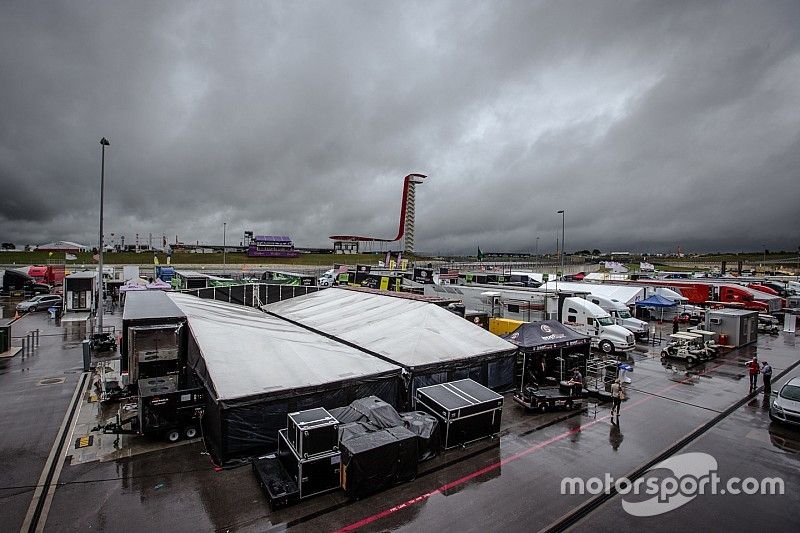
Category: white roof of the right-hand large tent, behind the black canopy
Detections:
[{"x1": 263, "y1": 288, "x2": 516, "y2": 368}]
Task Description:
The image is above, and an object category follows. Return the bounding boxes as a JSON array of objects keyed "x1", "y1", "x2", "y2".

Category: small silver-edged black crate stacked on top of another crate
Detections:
[{"x1": 286, "y1": 407, "x2": 339, "y2": 457}]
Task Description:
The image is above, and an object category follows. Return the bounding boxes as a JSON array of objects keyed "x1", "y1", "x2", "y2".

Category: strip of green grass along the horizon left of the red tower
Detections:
[{"x1": 0, "y1": 251, "x2": 413, "y2": 266}]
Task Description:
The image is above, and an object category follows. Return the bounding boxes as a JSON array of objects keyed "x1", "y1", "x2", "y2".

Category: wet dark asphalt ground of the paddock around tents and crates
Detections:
[{"x1": 0, "y1": 302, "x2": 800, "y2": 531}]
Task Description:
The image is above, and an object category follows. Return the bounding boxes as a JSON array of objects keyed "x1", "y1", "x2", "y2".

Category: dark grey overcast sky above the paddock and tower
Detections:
[{"x1": 0, "y1": 0, "x2": 800, "y2": 253}]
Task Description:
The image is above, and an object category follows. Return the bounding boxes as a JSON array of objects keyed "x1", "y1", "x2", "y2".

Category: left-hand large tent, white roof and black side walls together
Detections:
[{"x1": 162, "y1": 293, "x2": 404, "y2": 461}]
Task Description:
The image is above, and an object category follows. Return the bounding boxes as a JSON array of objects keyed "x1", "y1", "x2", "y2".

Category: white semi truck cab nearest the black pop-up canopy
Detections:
[{"x1": 561, "y1": 296, "x2": 636, "y2": 354}]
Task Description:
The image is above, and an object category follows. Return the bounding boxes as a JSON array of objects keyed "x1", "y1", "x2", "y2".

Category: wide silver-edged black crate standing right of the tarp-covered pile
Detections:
[{"x1": 415, "y1": 379, "x2": 503, "y2": 450}]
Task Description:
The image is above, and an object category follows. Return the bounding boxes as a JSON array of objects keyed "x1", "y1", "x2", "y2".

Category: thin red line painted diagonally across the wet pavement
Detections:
[{"x1": 336, "y1": 363, "x2": 723, "y2": 533}]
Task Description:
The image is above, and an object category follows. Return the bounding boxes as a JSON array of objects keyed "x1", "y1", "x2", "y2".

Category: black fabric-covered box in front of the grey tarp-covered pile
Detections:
[{"x1": 341, "y1": 426, "x2": 417, "y2": 498}]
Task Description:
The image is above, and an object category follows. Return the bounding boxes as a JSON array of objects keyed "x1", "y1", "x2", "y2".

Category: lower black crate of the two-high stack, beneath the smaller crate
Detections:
[{"x1": 278, "y1": 429, "x2": 341, "y2": 499}]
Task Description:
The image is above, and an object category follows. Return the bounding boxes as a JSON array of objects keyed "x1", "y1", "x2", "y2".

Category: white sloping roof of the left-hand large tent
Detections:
[{"x1": 168, "y1": 292, "x2": 401, "y2": 400}]
